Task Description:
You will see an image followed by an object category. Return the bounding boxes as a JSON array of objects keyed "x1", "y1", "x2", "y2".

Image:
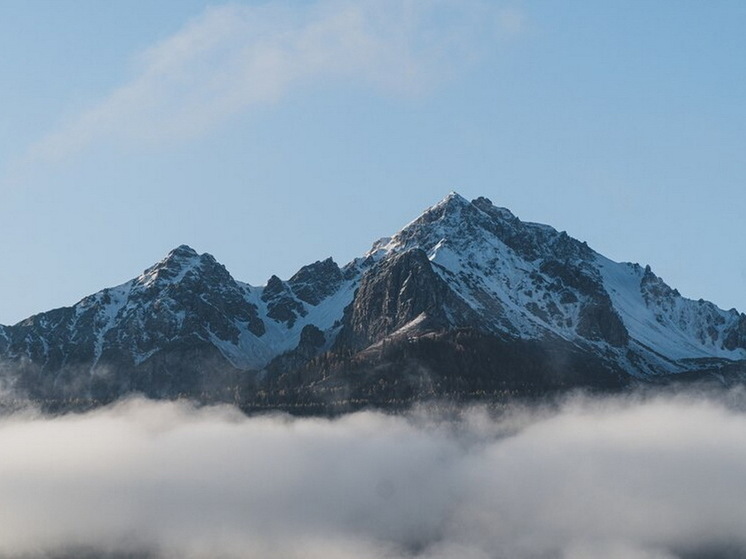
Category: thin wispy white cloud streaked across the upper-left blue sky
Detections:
[{"x1": 21, "y1": 0, "x2": 522, "y2": 164}]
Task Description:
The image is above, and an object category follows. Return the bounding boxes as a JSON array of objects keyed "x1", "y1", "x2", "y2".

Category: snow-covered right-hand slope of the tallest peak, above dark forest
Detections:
[{"x1": 352, "y1": 193, "x2": 746, "y2": 376}]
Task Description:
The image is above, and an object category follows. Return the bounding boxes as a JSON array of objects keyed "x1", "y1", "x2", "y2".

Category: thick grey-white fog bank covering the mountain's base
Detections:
[{"x1": 0, "y1": 392, "x2": 746, "y2": 559}]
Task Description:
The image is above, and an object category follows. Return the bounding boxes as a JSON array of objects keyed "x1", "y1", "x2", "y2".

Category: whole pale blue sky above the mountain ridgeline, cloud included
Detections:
[{"x1": 0, "y1": 0, "x2": 746, "y2": 324}]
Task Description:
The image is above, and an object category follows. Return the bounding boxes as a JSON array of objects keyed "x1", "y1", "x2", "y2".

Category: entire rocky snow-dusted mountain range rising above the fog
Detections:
[{"x1": 0, "y1": 193, "x2": 746, "y2": 409}]
